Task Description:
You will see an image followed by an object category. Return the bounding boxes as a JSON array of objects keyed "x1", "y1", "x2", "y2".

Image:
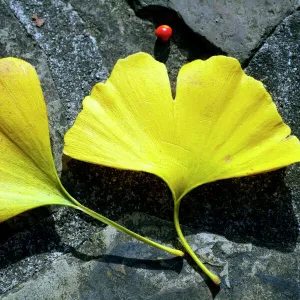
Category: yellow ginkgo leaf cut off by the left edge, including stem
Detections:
[{"x1": 0, "y1": 58, "x2": 183, "y2": 256}]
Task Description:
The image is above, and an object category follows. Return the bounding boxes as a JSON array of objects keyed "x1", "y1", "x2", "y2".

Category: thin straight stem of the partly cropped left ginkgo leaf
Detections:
[{"x1": 74, "y1": 199, "x2": 184, "y2": 256}]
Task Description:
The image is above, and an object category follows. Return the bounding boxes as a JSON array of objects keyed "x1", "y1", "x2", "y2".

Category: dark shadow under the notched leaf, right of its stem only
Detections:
[{"x1": 181, "y1": 170, "x2": 298, "y2": 252}]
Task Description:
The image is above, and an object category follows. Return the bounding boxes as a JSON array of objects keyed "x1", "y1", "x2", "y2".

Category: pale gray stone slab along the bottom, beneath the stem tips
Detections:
[{"x1": 2, "y1": 214, "x2": 299, "y2": 300}]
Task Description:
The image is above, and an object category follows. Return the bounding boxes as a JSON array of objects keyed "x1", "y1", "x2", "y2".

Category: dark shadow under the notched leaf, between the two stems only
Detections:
[{"x1": 62, "y1": 160, "x2": 173, "y2": 224}]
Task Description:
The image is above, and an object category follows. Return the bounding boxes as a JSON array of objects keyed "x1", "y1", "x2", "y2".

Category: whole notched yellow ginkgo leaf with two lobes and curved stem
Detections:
[{"x1": 64, "y1": 53, "x2": 300, "y2": 283}]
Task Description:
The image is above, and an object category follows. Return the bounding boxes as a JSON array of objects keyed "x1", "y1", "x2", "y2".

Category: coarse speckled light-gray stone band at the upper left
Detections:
[{"x1": 7, "y1": 0, "x2": 108, "y2": 124}]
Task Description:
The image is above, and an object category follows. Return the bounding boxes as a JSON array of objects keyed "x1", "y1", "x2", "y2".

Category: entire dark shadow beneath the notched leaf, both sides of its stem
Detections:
[{"x1": 63, "y1": 160, "x2": 298, "y2": 252}]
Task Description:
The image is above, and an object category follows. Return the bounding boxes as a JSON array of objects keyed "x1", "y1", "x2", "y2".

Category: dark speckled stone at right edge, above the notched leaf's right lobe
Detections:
[{"x1": 246, "y1": 12, "x2": 300, "y2": 136}]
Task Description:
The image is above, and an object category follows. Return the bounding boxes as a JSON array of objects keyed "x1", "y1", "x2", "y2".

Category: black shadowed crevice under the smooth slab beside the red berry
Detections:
[{"x1": 128, "y1": 1, "x2": 225, "y2": 62}]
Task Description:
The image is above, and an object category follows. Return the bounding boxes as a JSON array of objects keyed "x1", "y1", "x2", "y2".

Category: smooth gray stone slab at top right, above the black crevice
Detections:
[{"x1": 129, "y1": 0, "x2": 299, "y2": 62}]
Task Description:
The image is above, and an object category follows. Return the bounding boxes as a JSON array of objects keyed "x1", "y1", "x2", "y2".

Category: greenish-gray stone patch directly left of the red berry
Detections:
[{"x1": 69, "y1": 0, "x2": 155, "y2": 71}]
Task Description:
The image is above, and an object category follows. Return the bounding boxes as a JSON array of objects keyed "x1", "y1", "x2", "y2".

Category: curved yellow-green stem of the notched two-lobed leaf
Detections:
[{"x1": 174, "y1": 199, "x2": 221, "y2": 285}]
